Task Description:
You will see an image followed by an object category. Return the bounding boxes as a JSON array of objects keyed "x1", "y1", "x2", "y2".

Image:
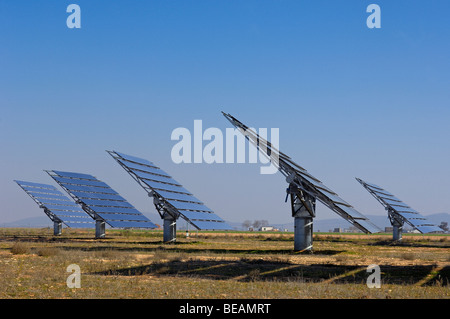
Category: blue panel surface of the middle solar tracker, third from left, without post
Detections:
[{"x1": 107, "y1": 151, "x2": 232, "y2": 230}]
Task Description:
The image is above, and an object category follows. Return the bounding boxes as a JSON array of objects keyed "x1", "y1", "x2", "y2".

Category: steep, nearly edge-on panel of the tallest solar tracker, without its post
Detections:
[{"x1": 222, "y1": 112, "x2": 382, "y2": 233}]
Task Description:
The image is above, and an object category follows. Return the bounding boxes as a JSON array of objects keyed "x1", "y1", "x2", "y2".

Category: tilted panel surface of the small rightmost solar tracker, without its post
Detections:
[{"x1": 356, "y1": 178, "x2": 442, "y2": 234}]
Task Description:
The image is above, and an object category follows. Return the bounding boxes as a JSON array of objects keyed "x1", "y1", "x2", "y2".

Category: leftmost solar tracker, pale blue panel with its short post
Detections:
[{"x1": 15, "y1": 180, "x2": 95, "y2": 235}]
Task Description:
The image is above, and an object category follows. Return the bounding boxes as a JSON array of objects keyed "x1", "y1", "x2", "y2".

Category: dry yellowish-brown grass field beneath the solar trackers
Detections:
[{"x1": 0, "y1": 228, "x2": 450, "y2": 299}]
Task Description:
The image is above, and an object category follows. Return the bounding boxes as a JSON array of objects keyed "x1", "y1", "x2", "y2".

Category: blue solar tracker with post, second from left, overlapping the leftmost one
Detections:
[{"x1": 46, "y1": 170, "x2": 156, "y2": 238}]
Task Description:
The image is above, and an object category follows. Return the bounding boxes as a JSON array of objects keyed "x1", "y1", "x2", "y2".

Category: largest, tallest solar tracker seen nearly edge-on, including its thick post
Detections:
[{"x1": 222, "y1": 112, "x2": 381, "y2": 251}]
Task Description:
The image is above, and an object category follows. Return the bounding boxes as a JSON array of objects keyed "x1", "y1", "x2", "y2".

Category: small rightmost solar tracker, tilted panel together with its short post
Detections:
[{"x1": 356, "y1": 178, "x2": 442, "y2": 240}]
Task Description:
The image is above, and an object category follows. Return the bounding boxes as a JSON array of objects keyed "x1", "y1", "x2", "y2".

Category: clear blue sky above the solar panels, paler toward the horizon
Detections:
[{"x1": 0, "y1": 0, "x2": 450, "y2": 223}]
